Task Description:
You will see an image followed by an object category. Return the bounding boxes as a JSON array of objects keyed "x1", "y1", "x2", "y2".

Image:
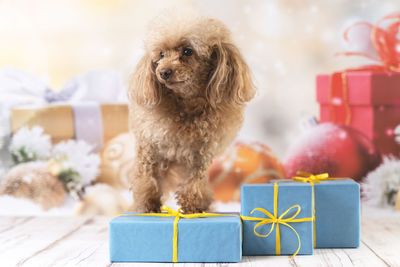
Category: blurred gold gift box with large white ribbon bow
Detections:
[{"x1": 0, "y1": 67, "x2": 129, "y2": 186}]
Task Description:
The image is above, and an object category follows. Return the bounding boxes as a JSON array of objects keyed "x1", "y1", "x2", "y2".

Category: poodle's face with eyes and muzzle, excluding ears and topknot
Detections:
[{"x1": 151, "y1": 38, "x2": 213, "y2": 98}]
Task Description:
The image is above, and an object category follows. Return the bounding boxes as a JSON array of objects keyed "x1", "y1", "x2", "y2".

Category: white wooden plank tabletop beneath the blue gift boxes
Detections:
[{"x1": 0, "y1": 215, "x2": 400, "y2": 267}]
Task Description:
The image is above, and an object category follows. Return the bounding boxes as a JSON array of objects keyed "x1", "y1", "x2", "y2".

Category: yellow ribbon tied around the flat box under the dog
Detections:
[{"x1": 120, "y1": 206, "x2": 238, "y2": 262}]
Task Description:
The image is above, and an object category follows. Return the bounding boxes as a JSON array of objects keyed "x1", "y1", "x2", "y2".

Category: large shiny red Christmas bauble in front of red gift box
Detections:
[{"x1": 284, "y1": 123, "x2": 381, "y2": 181}]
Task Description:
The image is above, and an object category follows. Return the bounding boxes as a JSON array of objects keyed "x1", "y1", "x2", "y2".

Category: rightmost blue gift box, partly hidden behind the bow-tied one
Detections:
[{"x1": 314, "y1": 179, "x2": 361, "y2": 248}]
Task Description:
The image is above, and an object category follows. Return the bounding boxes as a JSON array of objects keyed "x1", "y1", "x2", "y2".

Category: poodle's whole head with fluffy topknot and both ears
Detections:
[{"x1": 129, "y1": 17, "x2": 254, "y2": 107}]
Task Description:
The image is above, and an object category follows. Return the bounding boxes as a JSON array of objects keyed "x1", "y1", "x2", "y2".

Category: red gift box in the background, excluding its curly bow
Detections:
[{"x1": 317, "y1": 70, "x2": 400, "y2": 156}]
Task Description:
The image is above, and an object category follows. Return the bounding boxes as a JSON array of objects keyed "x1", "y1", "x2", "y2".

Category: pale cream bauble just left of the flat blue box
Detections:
[{"x1": 74, "y1": 184, "x2": 128, "y2": 217}]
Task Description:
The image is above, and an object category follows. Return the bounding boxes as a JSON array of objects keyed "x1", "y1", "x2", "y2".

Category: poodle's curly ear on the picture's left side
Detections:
[{"x1": 128, "y1": 54, "x2": 162, "y2": 107}]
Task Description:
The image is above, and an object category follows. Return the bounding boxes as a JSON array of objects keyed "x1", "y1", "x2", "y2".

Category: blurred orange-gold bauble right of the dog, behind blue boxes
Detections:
[{"x1": 209, "y1": 142, "x2": 284, "y2": 202}]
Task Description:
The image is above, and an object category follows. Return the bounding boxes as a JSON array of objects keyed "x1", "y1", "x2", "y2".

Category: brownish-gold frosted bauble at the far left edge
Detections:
[{"x1": 0, "y1": 162, "x2": 66, "y2": 210}]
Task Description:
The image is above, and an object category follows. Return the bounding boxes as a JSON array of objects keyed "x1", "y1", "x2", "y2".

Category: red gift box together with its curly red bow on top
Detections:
[{"x1": 317, "y1": 14, "x2": 400, "y2": 156}]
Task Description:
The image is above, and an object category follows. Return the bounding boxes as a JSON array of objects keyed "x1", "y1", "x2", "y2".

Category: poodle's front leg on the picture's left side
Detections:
[{"x1": 131, "y1": 146, "x2": 162, "y2": 212}]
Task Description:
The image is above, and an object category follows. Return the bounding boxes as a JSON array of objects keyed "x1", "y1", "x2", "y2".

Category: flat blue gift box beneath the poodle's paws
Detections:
[{"x1": 110, "y1": 213, "x2": 242, "y2": 262}]
